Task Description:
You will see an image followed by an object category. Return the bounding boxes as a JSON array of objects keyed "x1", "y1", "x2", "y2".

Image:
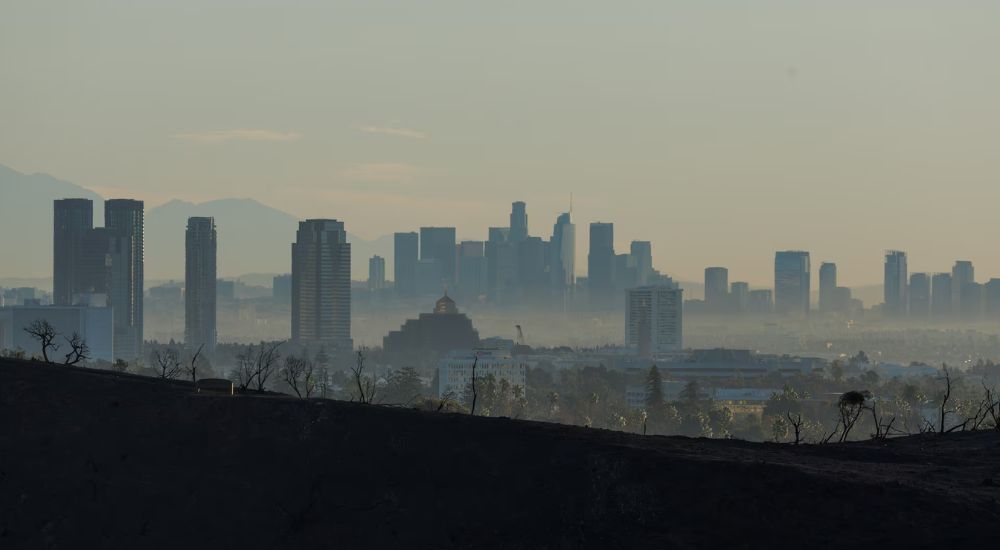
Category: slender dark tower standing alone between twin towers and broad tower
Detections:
[{"x1": 184, "y1": 218, "x2": 218, "y2": 355}]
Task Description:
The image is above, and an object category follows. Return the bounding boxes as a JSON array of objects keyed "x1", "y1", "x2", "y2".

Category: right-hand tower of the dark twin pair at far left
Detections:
[{"x1": 104, "y1": 199, "x2": 144, "y2": 360}]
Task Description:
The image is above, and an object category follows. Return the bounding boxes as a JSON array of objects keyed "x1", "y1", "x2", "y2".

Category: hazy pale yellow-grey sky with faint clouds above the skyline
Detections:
[{"x1": 0, "y1": 0, "x2": 1000, "y2": 284}]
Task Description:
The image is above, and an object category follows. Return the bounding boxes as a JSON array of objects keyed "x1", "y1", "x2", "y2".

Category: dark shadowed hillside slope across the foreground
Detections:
[{"x1": 0, "y1": 360, "x2": 1000, "y2": 549}]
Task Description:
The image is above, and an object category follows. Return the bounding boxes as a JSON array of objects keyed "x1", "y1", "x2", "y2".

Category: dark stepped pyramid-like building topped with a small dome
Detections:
[{"x1": 382, "y1": 293, "x2": 479, "y2": 354}]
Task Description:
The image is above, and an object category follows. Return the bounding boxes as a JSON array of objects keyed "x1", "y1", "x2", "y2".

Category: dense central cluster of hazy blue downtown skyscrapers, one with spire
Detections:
[{"x1": 393, "y1": 201, "x2": 672, "y2": 310}]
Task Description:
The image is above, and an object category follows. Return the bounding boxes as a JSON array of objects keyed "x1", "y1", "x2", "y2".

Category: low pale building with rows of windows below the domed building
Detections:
[{"x1": 437, "y1": 348, "x2": 528, "y2": 397}]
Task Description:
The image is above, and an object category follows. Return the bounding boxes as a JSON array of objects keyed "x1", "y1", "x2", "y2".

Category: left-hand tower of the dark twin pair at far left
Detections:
[{"x1": 52, "y1": 199, "x2": 94, "y2": 306}]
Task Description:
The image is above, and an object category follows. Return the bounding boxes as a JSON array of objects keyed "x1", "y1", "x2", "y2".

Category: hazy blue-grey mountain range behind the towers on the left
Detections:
[{"x1": 0, "y1": 165, "x2": 393, "y2": 280}]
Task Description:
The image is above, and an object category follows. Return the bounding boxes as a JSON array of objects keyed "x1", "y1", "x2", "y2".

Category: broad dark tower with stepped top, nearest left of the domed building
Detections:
[{"x1": 292, "y1": 220, "x2": 353, "y2": 351}]
